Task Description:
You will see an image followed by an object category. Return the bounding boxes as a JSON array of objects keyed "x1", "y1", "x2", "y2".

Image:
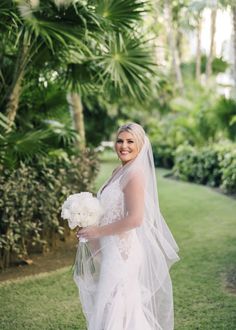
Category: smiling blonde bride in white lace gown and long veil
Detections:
[{"x1": 74, "y1": 123, "x2": 179, "y2": 330}]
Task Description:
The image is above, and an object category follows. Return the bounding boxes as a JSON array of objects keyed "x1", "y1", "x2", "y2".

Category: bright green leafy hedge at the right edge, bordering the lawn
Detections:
[{"x1": 173, "y1": 143, "x2": 236, "y2": 193}]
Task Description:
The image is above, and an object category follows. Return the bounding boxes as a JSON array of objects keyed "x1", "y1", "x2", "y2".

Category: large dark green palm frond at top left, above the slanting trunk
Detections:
[{"x1": 18, "y1": 0, "x2": 100, "y2": 55}]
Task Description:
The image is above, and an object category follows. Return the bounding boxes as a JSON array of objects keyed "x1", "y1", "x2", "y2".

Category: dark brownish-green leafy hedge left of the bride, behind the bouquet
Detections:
[{"x1": 0, "y1": 150, "x2": 98, "y2": 268}]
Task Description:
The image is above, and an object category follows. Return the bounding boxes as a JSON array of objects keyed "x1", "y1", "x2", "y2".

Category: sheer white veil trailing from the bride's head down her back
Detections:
[{"x1": 74, "y1": 135, "x2": 179, "y2": 330}]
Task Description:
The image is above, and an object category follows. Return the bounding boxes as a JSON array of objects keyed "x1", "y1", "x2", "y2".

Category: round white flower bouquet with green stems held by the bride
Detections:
[{"x1": 61, "y1": 192, "x2": 103, "y2": 275}]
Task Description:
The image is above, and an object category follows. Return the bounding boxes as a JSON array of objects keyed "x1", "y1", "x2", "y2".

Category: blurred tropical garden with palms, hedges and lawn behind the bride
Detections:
[{"x1": 0, "y1": 0, "x2": 236, "y2": 330}]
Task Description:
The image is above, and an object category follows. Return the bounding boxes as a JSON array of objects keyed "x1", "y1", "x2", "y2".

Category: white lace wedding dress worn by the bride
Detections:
[{"x1": 74, "y1": 135, "x2": 177, "y2": 330}]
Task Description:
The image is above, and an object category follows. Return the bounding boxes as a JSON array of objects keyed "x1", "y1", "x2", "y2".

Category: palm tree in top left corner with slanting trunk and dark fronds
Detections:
[{"x1": 0, "y1": 0, "x2": 91, "y2": 126}]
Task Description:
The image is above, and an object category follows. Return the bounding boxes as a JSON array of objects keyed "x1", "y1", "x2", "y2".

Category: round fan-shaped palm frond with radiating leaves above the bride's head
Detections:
[{"x1": 95, "y1": 34, "x2": 155, "y2": 99}]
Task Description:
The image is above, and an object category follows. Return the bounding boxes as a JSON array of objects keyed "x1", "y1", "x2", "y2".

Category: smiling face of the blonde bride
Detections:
[{"x1": 115, "y1": 132, "x2": 139, "y2": 165}]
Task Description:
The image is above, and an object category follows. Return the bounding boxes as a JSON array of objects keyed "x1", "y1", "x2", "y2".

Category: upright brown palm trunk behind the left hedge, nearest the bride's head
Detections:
[{"x1": 68, "y1": 92, "x2": 85, "y2": 150}]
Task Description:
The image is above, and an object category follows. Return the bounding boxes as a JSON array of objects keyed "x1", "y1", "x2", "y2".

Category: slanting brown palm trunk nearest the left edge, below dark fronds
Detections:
[{"x1": 6, "y1": 43, "x2": 29, "y2": 130}]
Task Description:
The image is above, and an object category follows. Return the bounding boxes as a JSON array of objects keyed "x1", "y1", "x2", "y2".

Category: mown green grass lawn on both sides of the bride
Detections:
[{"x1": 0, "y1": 162, "x2": 236, "y2": 330}]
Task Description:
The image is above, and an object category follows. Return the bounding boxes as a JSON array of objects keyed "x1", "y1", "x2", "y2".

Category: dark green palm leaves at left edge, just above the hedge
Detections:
[{"x1": 0, "y1": 121, "x2": 78, "y2": 170}]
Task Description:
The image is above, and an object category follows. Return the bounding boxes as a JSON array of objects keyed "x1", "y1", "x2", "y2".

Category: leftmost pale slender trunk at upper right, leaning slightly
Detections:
[{"x1": 165, "y1": 0, "x2": 184, "y2": 94}]
